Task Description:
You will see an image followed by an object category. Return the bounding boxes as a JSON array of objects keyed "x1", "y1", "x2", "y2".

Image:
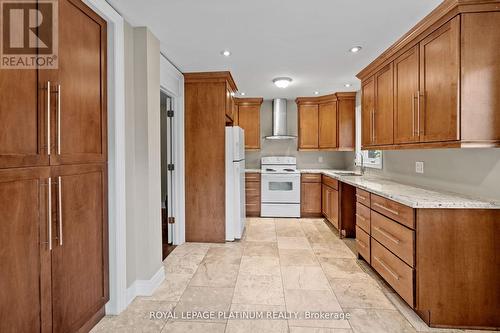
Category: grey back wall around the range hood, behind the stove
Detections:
[{"x1": 245, "y1": 100, "x2": 345, "y2": 169}]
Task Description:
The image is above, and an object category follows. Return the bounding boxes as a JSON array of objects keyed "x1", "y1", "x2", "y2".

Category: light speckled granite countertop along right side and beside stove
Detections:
[{"x1": 246, "y1": 169, "x2": 500, "y2": 209}]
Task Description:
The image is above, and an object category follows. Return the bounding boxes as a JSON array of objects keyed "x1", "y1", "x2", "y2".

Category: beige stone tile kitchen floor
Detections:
[{"x1": 92, "y1": 218, "x2": 498, "y2": 333}]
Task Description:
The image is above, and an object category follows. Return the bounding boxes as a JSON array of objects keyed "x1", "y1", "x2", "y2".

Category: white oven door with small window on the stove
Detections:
[{"x1": 261, "y1": 173, "x2": 300, "y2": 203}]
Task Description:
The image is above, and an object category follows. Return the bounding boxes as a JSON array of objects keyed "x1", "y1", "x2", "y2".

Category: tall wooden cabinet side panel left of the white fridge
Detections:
[{"x1": 184, "y1": 72, "x2": 237, "y2": 243}]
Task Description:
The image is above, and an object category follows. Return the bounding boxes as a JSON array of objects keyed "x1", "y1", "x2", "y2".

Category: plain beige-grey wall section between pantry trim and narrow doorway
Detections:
[{"x1": 124, "y1": 23, "x2": 163, "y2": 293}]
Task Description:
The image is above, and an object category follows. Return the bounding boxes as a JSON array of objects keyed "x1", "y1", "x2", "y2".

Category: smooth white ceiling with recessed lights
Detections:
[{"x1": 107, "y1": 0, "x2": 441, "y2": 99}]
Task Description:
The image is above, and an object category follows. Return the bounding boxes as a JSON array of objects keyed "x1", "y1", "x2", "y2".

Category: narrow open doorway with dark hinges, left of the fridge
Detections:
[{"x1": 160, "y1": 91, "x2": 175, "y2": 259}]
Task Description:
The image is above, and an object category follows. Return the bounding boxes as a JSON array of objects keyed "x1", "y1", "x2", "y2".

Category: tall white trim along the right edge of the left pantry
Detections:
[{"x1": 84, "y1": 0, "x2": 128, "y2": 314}]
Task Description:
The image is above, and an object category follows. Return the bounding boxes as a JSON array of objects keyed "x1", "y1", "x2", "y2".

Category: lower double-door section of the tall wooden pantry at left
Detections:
[{"x1": 0, "y1": 165, "x2": 108, "y2": 332}]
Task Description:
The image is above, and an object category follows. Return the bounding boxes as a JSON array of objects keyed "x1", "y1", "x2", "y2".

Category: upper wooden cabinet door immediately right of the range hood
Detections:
[{"x1": 299, "y1": 104, "x2": 319, "y2": 150}]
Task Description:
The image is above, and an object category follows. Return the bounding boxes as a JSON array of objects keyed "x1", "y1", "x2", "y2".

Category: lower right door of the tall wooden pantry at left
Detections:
[{"x1": 52, "y1": 164, "x2": 108, "y2": 332}]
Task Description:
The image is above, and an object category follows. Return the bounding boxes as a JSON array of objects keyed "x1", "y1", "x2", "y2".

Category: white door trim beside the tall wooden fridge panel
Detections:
[{"x1": 160, "y1": 54, "x2": 186, "y2": 245}]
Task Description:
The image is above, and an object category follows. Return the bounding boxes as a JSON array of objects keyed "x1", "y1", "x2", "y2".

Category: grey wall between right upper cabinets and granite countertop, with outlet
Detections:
[{"x1": 346, "y1": 93, "x2": 500, "y2": 200}]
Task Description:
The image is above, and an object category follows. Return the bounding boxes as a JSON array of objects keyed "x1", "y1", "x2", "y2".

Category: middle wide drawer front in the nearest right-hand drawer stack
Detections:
[{"x1": 371, "y1": 211, "x2": 415, "y2": 267}]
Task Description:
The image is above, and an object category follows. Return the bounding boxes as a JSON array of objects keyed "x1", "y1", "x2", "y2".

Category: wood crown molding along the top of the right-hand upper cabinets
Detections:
[{"x1": 356, "y1": 0, "x2": 500, "y2": 81}]
